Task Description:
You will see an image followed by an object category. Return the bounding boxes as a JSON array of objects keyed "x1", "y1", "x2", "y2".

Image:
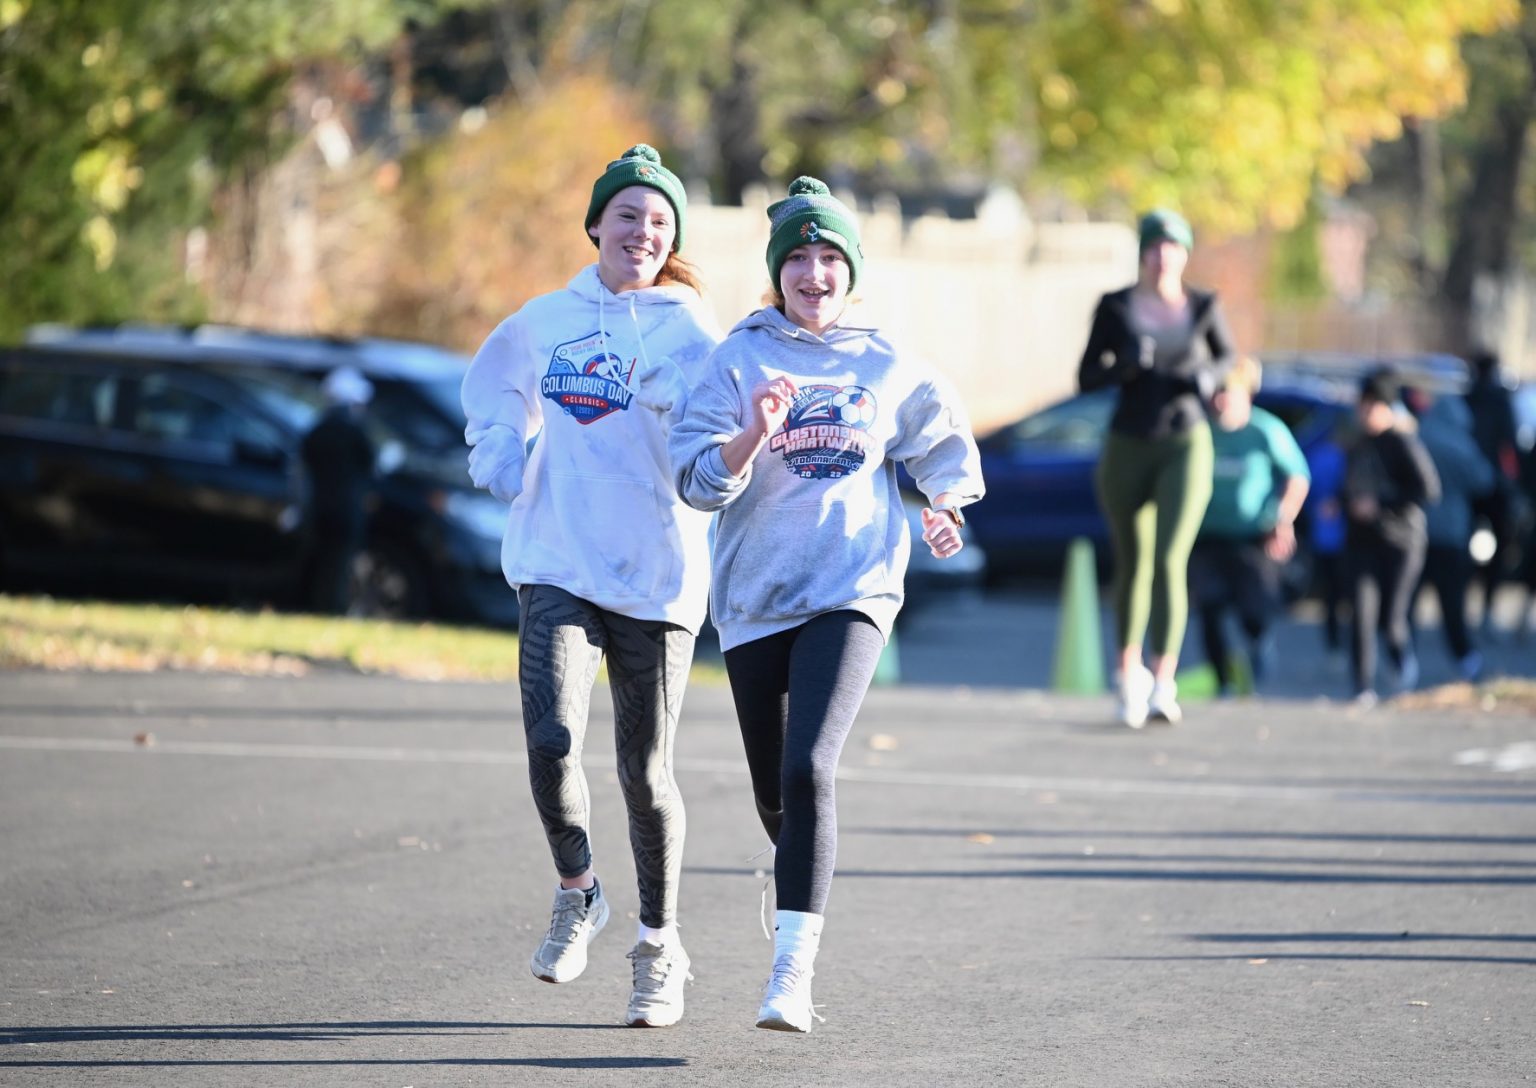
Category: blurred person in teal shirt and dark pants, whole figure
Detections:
[{"x1": 1189, "y1": 355, "x2": 1312, "y2": 695}]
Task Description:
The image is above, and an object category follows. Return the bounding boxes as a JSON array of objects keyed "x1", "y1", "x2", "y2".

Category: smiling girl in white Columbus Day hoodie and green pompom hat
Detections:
[{"x1": 462, "y1": 144, "x2": 719, "y2": 1027}]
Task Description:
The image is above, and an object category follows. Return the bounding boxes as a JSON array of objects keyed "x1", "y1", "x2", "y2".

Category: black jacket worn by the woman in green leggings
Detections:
[{"x1": 1077, "y1": 287, "x2": 1235, "y2": 438}]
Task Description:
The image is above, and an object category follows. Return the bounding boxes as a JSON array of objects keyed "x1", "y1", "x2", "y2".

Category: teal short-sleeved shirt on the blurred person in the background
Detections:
[{"x1": 1200, "y1": 407, "x2": 1312, "y2": 539}]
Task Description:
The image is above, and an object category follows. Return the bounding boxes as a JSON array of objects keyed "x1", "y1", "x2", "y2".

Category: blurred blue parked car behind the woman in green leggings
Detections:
[{"x1": 969, "y1": 355, "x2": 1465, "y2": 585}]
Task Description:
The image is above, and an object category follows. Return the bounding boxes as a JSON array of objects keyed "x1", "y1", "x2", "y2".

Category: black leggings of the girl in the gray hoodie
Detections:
[{"x1": 725, "y1": 612, "x2": 885, "y2": 914}]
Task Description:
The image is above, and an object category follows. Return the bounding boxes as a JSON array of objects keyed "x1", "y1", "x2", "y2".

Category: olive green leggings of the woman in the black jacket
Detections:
[{"x1": 1094, "y1": 423, "x2": 1215, "y2": 658}]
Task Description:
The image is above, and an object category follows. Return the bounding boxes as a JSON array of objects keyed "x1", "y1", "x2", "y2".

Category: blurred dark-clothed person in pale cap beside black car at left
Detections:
[{"x1": 300, "y1": 366, "x2": 378, "y2": 615}]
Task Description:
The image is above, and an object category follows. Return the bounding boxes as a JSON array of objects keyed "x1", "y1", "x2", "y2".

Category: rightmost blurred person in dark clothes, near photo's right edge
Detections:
[{"x1": 1465, "y1": 350, "x2": 1524, "y2": 635}]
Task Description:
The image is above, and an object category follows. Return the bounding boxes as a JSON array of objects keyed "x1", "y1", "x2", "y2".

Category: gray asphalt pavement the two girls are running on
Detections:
[{"x1": 0, "y1": 651, "x2": 1536, "y2": 1088}]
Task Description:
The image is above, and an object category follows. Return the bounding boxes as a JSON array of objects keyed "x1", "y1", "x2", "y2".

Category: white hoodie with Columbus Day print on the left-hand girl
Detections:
[{"x1": 462, "y1": 264, "x2": 720, "y2": 635}]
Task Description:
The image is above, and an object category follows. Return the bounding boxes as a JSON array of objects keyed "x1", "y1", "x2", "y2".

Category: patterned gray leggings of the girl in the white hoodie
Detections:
[{"x1": 518, "y1": 585, "x2": 694, "y2": 927}]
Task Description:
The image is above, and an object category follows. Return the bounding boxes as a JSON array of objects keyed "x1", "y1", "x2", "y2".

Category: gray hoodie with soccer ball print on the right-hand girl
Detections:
[{"x1": 668, "y1": 306, "x2": 983, "y2": 650}]
